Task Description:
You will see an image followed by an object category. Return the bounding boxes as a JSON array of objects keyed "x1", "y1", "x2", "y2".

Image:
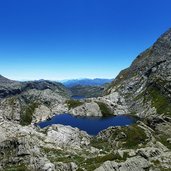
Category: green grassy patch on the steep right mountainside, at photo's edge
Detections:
[{"x1": 148, "y1": 86, "x2": 171, "y2": 115}]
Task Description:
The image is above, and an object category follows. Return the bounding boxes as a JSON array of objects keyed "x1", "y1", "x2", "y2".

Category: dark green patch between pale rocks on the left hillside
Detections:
[{"x1": 20, "y1": 102, "x2": 39, "y2": 125}]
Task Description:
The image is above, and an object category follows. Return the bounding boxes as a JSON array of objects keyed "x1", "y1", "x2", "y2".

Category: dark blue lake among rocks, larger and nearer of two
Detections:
[{"x1": 37, "y1": 114, "x2": 137, "y2": 135}]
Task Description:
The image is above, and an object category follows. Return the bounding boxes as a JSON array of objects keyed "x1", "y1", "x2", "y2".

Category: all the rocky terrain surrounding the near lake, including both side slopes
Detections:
[{"x1": 0, "y1": 30, "x2": 171, "y2": 171}]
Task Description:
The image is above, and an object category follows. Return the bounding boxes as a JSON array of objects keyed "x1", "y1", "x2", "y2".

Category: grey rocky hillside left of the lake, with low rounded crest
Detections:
[{"x1": 0, "y1": 76, "x2": 70, "y2": 125}]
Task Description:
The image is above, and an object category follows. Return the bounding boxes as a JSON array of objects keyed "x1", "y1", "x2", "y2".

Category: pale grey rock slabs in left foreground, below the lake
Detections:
[{"x1": 0, "y1": 118, "x2": 90, "y2": 171}]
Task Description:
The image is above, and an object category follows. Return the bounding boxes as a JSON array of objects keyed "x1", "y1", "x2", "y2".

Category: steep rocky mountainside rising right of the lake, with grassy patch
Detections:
[{"x1": 106, "y1": 29, "x2": 171, "y2": 117}]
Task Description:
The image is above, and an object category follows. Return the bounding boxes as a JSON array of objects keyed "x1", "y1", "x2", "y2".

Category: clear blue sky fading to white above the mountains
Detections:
[{"x1": 0, "y1": 0, "x2": 171, "y2": 80}]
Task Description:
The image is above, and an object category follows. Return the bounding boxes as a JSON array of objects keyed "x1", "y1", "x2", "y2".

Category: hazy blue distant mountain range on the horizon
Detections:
[{"x1": 61, "y1": 78, "x2": 113, "y2": 87}]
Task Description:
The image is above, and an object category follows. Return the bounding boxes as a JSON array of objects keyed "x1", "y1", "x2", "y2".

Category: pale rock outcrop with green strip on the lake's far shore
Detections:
[{"x1": 69, "y1": 92, "x2": 129, "y2": 117}]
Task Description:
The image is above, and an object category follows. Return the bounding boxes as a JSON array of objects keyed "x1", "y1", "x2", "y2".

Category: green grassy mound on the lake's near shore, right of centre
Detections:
[{"x1": 91, "y1": 124, "x2": 147, "y2": 152}]
